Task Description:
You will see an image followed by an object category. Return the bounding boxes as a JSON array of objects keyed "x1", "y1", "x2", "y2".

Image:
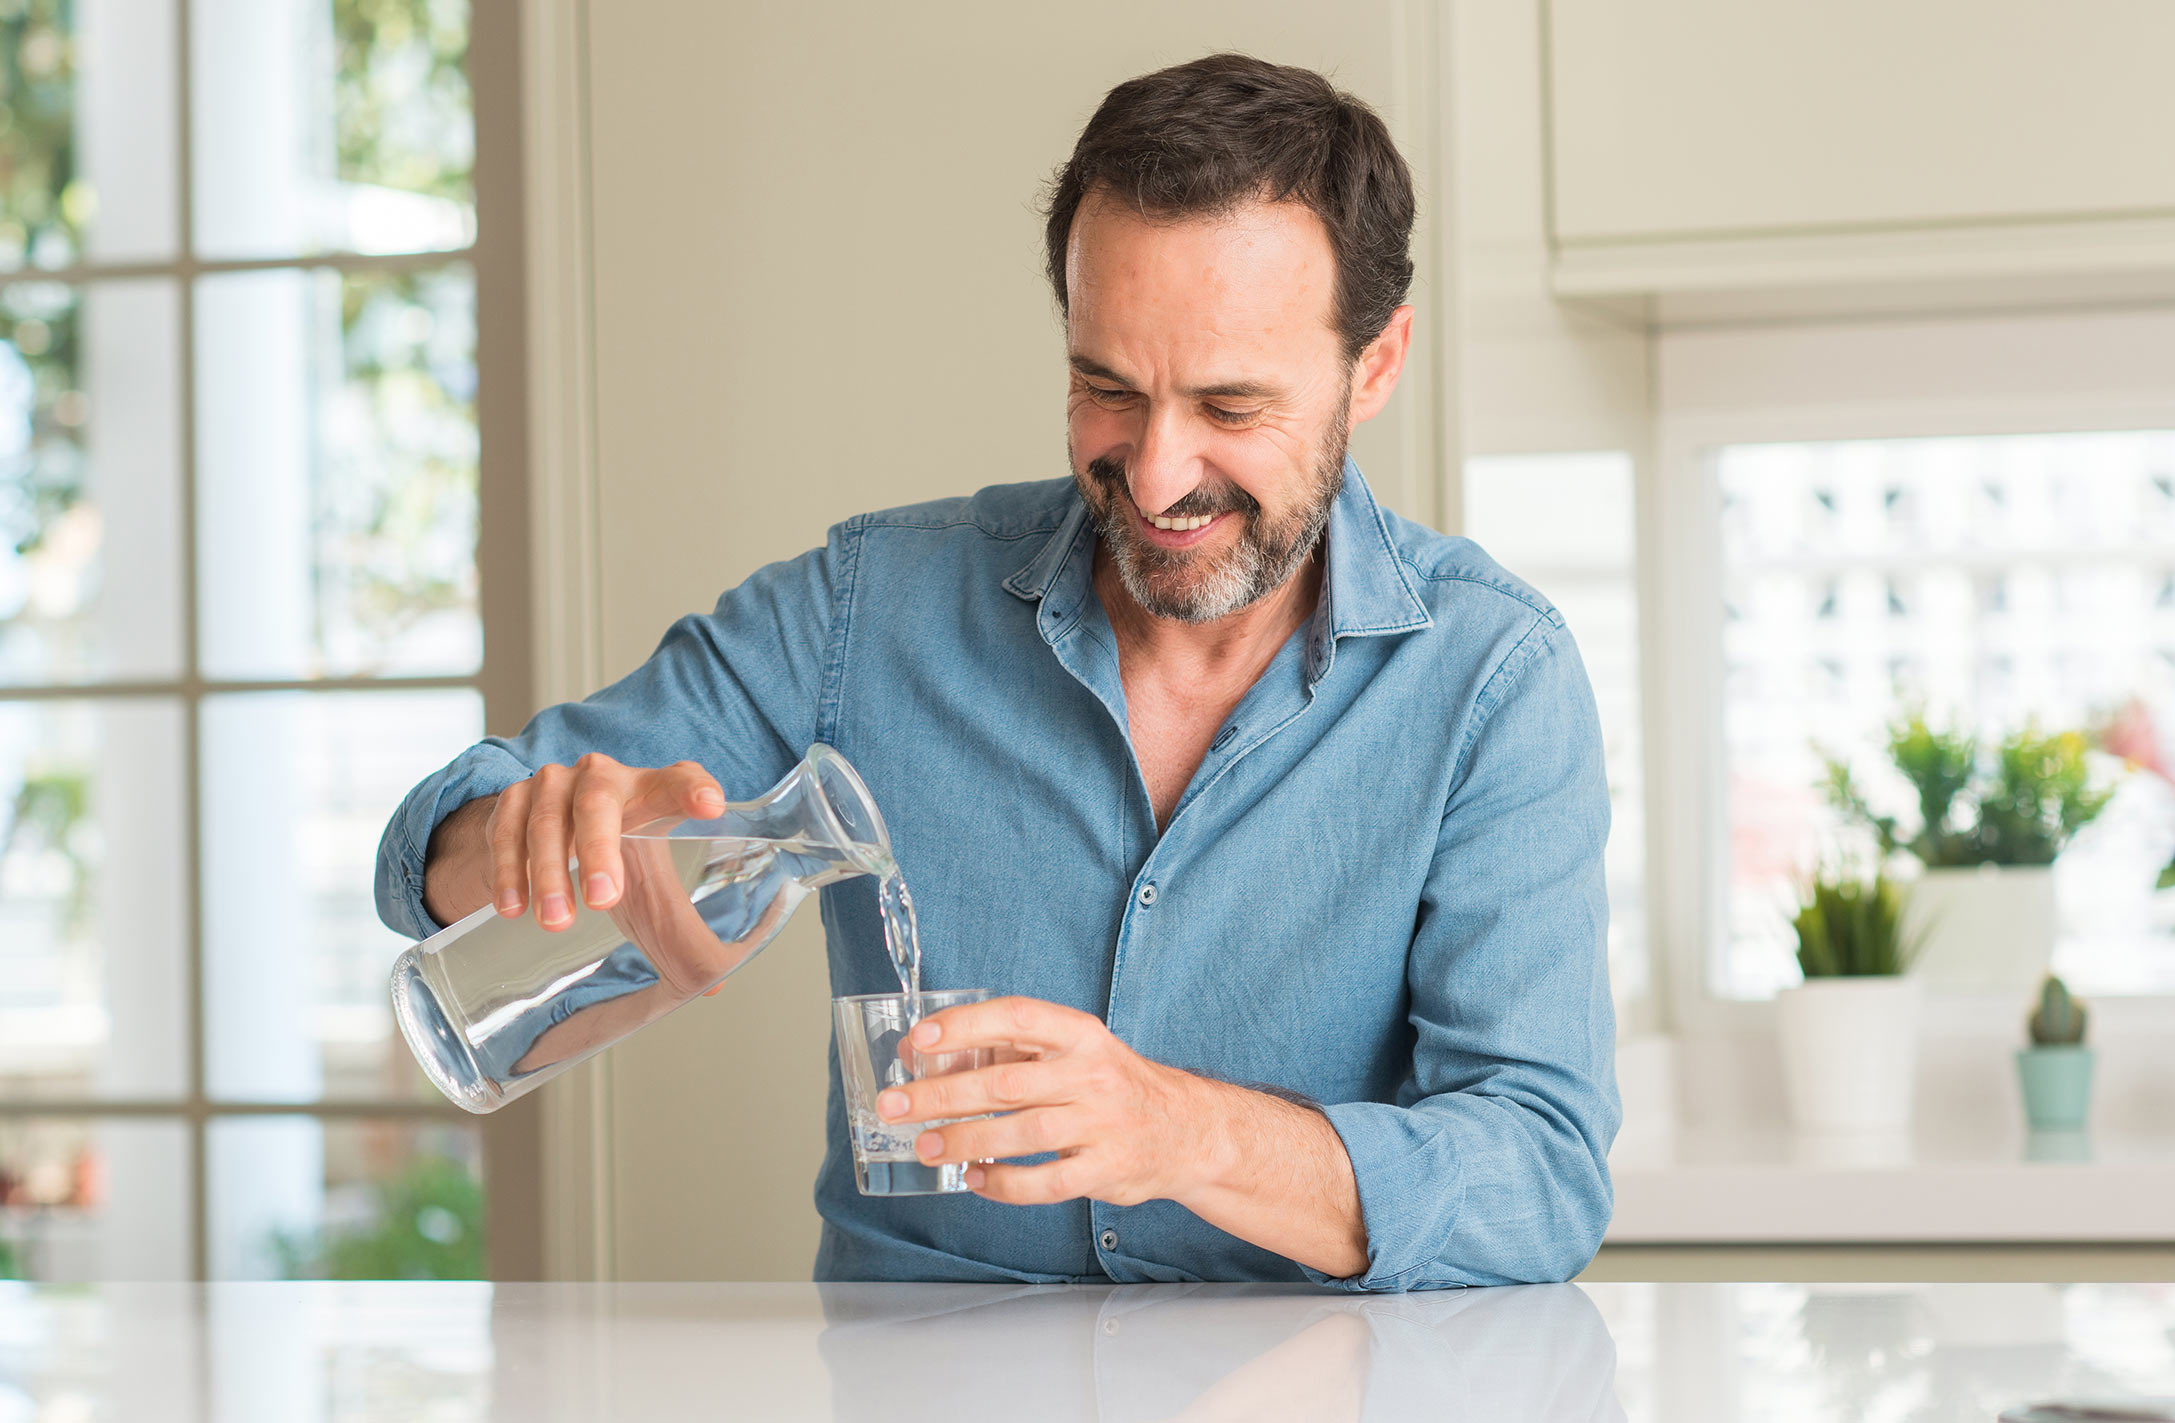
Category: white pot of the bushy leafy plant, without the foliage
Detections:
[{"x1": 1903, "y1": 864, "x2": 2055, "y2": 992}]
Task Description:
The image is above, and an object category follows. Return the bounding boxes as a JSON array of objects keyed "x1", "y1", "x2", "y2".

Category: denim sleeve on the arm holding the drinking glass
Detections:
[{"x1": 1309, "y1": 618, "x2": 1620, "y2": 1290}]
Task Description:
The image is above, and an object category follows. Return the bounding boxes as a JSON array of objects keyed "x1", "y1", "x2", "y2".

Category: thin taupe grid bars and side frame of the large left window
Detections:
[{"x1": 0, "y1": 0, "x2": 544, "y2": 1279}]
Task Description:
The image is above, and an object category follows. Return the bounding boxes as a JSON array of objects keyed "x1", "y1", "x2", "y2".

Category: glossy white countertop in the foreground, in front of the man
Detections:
[{"x1": 0, "y1": 1284, "x2": 2175, "y2": 1423}]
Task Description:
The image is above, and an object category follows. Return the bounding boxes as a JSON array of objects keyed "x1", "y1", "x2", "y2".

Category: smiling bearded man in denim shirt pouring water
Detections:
[{"x1": 378, "y1": 54, "x2": 1618, "y2": 1290}]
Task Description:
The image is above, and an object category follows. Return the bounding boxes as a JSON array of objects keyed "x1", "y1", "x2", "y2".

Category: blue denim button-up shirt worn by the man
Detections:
[{"x1": 376, "y1": 466, "x2": 1618, "y2": 1290}]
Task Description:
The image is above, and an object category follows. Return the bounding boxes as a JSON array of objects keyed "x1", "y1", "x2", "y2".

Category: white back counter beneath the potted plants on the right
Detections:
[{"x1": 1607, "y1": 1127, "x2": 2175, "y2": 1245}]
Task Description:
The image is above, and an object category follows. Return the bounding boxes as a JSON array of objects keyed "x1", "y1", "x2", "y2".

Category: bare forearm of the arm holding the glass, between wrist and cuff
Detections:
[{"x1": 1177, "y1": 1079, "x2": 1368, "y2": 1279}]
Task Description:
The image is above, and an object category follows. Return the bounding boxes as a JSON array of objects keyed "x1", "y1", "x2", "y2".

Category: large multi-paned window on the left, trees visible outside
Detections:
[{"x1": 0, "y1": 0, "x2": 526, "y2": 1279}]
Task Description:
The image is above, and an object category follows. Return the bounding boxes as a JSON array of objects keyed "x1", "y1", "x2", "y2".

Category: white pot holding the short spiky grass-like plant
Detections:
[{"x1": 1775, "y1": 977, "x2": 1918, "y2": 1131}]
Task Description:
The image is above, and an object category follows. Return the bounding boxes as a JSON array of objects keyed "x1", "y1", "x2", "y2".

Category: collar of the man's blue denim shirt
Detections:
[{"x1": 1005, "y1": 455, "x2": 1433, "y2": 683}]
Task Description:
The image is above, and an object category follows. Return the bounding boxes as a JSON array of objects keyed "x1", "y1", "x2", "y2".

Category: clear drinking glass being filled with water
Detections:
[{"x1": 831, "y1": 988, "x2": 996, "y2": 1197}]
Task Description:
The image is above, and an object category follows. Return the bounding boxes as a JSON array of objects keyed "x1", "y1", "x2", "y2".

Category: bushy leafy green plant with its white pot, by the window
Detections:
[{"x1": 1825, "y1": 716, "x2": 2112, "y2": 992}]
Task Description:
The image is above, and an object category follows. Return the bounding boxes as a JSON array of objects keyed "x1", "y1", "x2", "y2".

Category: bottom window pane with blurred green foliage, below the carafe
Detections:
[{"x1": 207, "y1": 1116, "x2": 485, "y2": 1279}]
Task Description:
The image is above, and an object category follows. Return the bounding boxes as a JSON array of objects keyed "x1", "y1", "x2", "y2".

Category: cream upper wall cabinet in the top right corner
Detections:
[{"x1": 1546, "y1": 0, "x2": 2175, "y2": 304}]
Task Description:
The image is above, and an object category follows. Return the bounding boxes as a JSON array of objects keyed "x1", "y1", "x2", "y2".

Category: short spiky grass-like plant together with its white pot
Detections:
[{"x1": 1775, "y1": 873, "x2": 1918, "y2": 1131}]
